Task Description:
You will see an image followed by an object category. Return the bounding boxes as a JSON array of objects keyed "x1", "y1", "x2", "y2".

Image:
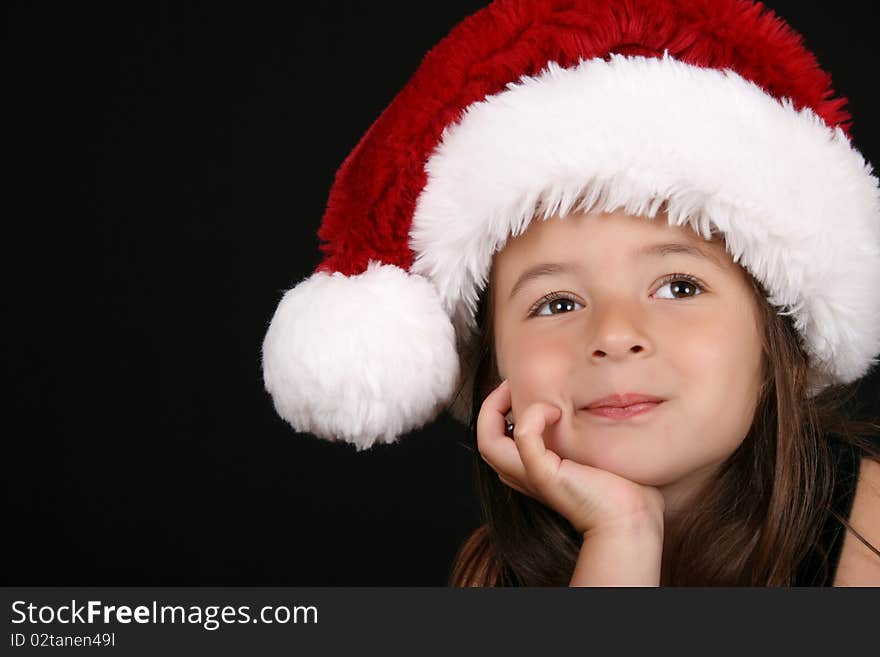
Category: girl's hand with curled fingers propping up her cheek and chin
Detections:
[{"x1": 477, "y1": 381, "x2": 664, "y2": 534}]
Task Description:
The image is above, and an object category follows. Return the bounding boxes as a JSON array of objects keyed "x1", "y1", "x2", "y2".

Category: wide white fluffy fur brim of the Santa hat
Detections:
[{"x1": 410, "y1": 55, "x2": 880, "y2": 416}]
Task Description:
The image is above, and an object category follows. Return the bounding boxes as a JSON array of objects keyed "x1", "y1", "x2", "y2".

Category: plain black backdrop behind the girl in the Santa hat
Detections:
[{"x1": 2, "y1": 1, "x2": 880, "y2": 586}]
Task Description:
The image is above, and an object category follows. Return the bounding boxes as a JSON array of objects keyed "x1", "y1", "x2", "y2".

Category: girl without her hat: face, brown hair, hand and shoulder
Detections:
[{"x1": 451, "y1": 205, "x2": 880, "y2": 585}]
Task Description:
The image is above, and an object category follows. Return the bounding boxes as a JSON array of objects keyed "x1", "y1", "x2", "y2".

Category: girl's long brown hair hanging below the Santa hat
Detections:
[{"x1": 449, "y1": 255, "x2": 880, "y2": 586}]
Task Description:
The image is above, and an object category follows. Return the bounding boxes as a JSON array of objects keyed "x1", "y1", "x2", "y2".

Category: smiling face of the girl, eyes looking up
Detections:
[{"x1": 490, "y1": 208, "x2": 763, "y2": 487}]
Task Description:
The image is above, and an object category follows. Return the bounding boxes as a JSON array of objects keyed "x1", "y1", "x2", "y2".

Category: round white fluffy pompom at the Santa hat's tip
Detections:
[{"x1": 262, "y1": 261, "x2": 459, "y2": 451}]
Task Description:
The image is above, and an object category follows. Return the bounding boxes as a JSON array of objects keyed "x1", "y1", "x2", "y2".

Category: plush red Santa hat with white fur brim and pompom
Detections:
[{"x1": 262, "y1": 0, "x2": 880, "y2": 449}]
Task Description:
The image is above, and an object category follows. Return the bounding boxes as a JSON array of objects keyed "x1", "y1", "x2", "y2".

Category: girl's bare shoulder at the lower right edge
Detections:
[{"x1": 833, "y1": 454, "x2": 880, "y2": 586}]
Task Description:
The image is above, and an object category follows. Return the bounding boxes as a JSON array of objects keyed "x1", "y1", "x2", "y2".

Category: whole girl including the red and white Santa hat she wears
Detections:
[{"x1": 262, "y1": 0, "x2": 880, "y2": 585}]
